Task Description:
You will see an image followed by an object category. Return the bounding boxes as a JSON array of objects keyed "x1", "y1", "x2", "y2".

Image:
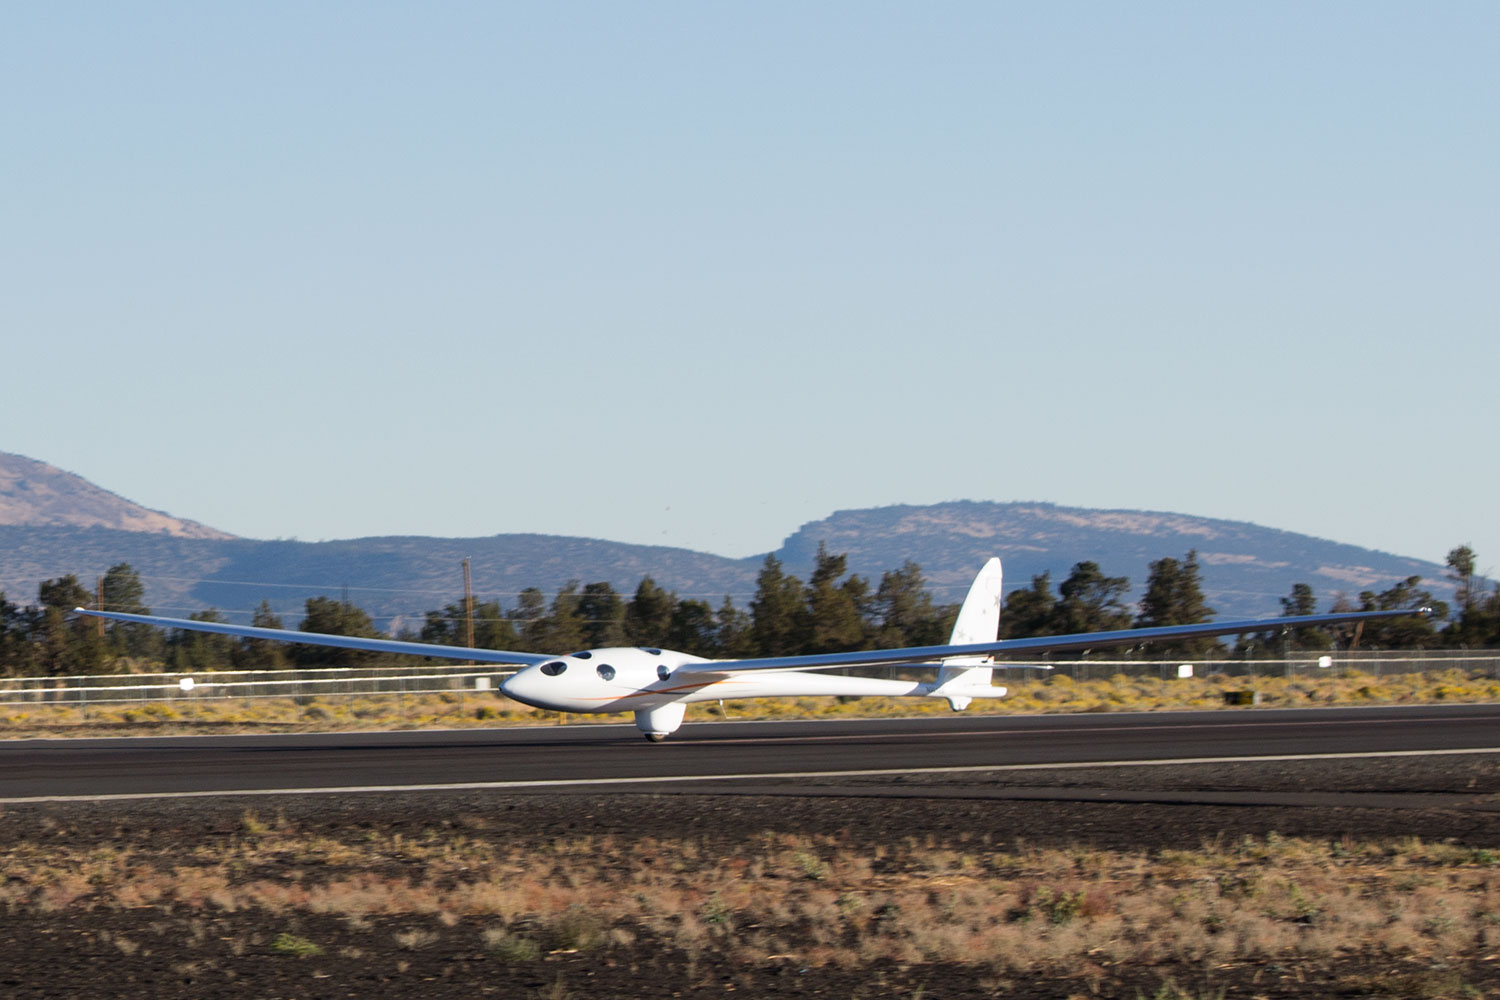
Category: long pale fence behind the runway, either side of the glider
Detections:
[{"x1": 0, "y1": 649, "x2": 1500, "y2": 711}]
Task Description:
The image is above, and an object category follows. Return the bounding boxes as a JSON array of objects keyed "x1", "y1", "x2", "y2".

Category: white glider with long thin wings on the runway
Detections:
[{"x1": 74, "y1": 559, "x2": 1427, "y2": 741}]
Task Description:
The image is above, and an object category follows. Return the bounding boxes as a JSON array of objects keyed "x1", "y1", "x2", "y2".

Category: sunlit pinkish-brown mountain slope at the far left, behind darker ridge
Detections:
[{"x1": 0, "y1": 451, "x2": 234, "y2": 538}]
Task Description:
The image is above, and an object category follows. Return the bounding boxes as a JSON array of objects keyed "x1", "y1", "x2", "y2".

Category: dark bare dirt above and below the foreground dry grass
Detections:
[{"x1": 0, "y1": 757, "x2": 1500, "y2": 1000}]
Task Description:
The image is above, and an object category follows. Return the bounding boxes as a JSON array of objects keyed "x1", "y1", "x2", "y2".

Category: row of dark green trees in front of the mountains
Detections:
[{"x1": 0, "y1": 546, "x2": 1500, "y2": 676}]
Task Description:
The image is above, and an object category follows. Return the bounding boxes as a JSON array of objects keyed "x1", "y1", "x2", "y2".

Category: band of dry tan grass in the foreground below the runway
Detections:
[{"x1": 0, "y1": 814, "x2": 1500, "y2": 973}]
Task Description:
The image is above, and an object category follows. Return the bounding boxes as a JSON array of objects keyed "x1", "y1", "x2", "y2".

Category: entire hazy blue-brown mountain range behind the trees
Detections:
[{"x1": 0, "y1": 453, "x2": 1452, "y2": 628}]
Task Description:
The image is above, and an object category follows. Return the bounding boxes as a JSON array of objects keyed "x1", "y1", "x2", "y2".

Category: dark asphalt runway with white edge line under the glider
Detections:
[{"x1": 0, "y1": 705, "x2": 1500, "y2": 805}]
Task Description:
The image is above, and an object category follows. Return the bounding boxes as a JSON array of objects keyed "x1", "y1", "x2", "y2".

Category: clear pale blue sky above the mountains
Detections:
[{"x1": 0, "y1": 0, "x2": 1500, "y2": 574}]
